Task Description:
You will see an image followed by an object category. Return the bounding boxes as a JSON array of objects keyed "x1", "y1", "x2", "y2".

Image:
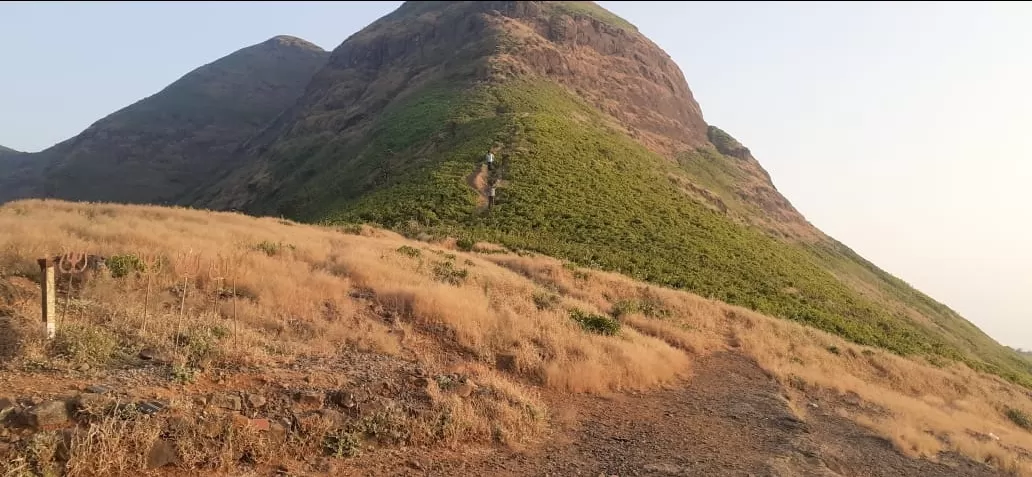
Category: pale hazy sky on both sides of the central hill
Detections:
[{"x1": 0, "y1": 2, "x2": 1032, "y2": 348}]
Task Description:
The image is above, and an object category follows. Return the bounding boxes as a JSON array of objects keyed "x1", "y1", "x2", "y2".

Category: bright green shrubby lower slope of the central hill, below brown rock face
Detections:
[{"x1": 260, "y1": 77, "x2": 1032, "y2": 383}]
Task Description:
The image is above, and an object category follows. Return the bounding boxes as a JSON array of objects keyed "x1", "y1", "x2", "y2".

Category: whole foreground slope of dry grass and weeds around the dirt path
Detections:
[{"x1": 6, "y1": 200, "x2": 1032, "y2": 476}]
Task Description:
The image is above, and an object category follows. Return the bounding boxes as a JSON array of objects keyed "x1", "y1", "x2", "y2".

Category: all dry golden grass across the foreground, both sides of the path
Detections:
[{"x1": 0, "y1": 200, "x2": 1032, "y2": 475}]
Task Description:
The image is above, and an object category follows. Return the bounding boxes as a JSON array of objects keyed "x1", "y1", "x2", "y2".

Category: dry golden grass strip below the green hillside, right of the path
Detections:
[{"x1": 480, "y1": 255, "x2": 1032, "y2": 476}]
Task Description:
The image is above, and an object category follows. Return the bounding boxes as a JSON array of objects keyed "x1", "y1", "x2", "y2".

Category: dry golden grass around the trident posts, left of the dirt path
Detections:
[{"x1": 0, "y1": 200, "x2": 688, "y2": 474}]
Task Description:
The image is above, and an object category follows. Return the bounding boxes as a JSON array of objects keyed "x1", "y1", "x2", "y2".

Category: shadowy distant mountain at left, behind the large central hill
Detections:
[{"x1": 0, "y1": 36, "x2": 328, "y2": 203}]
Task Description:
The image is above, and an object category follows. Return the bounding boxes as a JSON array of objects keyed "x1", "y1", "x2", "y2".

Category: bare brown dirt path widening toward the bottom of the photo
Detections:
[{"x1": 347, "y1": 352, "x2": 998, "y2": 477}]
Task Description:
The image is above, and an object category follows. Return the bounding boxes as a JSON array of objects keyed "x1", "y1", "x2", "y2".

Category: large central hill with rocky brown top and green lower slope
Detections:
[{"x1": 190, "y1": 2, "x2": 1032, "y2": 384}]
